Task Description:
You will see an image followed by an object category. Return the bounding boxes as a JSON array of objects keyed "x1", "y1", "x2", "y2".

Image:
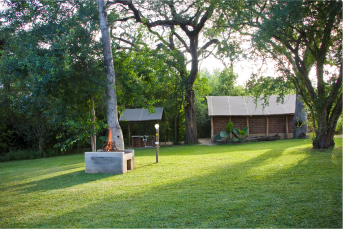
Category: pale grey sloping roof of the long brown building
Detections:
[{"x1": 207, "y1": 95, "x2": 296, "y2": 116}]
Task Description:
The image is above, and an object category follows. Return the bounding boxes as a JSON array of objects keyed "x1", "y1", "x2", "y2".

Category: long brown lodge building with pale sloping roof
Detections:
[{"x1": 207, "y1": 95, "x2": 296, "y2": 141}]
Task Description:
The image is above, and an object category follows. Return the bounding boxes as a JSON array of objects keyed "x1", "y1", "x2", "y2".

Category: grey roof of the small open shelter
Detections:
[{"x1": 119, "y1": 107, "x2": 164, "y2": 122}]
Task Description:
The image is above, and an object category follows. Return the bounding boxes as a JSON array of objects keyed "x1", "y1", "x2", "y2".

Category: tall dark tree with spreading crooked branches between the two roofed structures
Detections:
[{"x1": 108, "y1": 0, "x2": 231, "y2": 143}]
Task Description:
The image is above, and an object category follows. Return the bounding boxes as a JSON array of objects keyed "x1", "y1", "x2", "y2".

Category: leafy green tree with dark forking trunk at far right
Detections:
[{"x1": 239, "y1": 0, "x2": 343, "y2": 148}]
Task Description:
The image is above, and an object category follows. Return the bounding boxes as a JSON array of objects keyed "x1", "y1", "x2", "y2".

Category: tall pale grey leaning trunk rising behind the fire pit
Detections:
[{"x1": 98, "y1": 0, "x2": 124, "y2": 150}]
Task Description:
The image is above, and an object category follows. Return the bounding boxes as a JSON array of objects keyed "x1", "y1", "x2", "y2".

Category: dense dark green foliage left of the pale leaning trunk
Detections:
[{"x1": 0, "y1": 0, "x2": 109, "y2": 156}]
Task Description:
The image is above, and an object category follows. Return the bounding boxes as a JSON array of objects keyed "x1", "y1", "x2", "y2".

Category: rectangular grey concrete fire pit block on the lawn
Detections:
[{"x1": 85, "y1": 150, "x2": 135, "y2": 174}]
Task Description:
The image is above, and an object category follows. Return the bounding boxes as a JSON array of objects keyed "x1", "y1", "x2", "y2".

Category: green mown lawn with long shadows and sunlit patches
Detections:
[{"x1": 0, "y1": 138, "x2": 343, "y2": 228}]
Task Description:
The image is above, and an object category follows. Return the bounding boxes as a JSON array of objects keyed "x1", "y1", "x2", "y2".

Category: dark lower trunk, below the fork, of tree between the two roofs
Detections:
[{"x1": 185, "y1": 88, "x2": 198, "y2": 144}]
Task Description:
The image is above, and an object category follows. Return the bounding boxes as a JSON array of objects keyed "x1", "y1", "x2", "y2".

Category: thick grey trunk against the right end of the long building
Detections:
[{"x1": 293, "y1": 94, "x2": 308, "y2": 138}]
